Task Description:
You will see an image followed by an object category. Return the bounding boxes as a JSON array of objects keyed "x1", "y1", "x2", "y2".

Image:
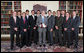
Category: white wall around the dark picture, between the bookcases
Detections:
[{"x1": 21, "y1": 1, "x2": 59, "y2": 14}]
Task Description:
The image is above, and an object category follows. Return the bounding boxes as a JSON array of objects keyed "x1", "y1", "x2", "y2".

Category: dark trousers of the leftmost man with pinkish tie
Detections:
[{"x1": 10, "y1": 30, "x2": 20, "y2": 49}]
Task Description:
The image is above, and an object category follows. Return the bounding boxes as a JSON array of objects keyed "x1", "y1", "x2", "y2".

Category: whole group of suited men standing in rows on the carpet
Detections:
[{"x1": 9, "y1": 10, "x2": 80, "y2": 49}]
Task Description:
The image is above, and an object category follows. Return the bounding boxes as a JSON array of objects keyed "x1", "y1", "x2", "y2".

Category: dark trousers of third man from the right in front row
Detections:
[{"x1": 55, "y1": 30, "x2": 63, "y2": 46}]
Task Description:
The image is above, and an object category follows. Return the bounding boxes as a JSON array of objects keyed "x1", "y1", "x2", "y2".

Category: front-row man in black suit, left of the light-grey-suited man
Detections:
[{"x1": 30, "y1": 10, "x2": 37, "y2": 44}]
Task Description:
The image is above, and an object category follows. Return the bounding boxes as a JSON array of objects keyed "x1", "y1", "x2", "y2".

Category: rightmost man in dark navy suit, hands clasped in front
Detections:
[{"x1": 71, "y1": 11, "x2": 80, "y2": 51}]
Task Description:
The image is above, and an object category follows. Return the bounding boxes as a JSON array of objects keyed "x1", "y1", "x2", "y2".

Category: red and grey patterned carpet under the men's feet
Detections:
[{"x1": 1, "y1": 40, "x2": 83, "y2": 52}]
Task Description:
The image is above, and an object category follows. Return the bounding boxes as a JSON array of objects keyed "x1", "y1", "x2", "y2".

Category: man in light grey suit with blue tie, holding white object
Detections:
[{"x1": 37, "y1": 11, "x2": 48, "y2": 46}]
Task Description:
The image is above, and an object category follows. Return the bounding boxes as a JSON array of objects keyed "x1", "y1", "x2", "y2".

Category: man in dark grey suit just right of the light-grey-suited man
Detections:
[{"x1": 47, "y1": 10, "x2": 55, "y2": 46}]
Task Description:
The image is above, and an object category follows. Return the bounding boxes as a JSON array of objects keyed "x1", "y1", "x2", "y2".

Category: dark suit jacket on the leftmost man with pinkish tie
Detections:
[{"x1": 9, "y1": 16, "x2": 19, "y2": 31}]
